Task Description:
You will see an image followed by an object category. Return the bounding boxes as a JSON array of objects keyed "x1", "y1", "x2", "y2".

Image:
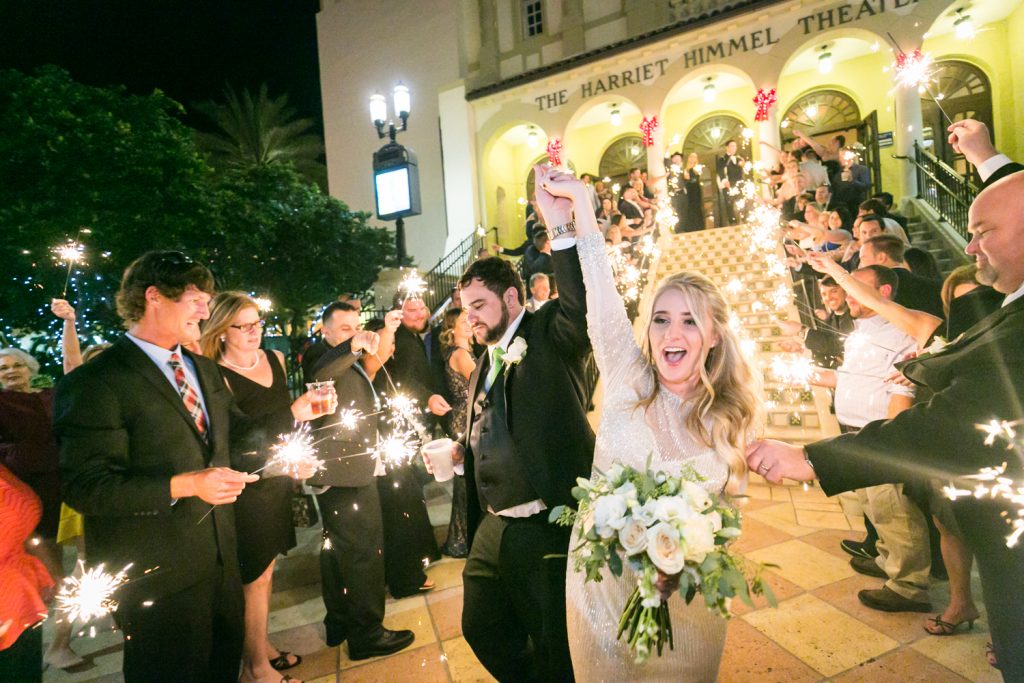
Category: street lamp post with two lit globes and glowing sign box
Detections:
[{"x1": 370, "y1": 81, "x2": 420, "y2": 265}]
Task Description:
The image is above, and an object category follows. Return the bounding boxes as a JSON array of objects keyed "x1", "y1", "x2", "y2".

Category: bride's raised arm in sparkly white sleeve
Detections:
[{"x1": 538, "y1": 169, "x2": 643, "y2": 387}]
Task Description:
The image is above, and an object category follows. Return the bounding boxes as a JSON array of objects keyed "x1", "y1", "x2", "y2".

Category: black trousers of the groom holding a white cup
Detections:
[{"x1": 462, "y1": 511, "x2": 574, "y2": 683}]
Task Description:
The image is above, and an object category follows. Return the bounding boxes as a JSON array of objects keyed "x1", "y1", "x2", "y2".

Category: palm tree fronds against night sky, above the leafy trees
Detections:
[{"x1": 196, "y1": 83, "x2": 327, "y2": 187}]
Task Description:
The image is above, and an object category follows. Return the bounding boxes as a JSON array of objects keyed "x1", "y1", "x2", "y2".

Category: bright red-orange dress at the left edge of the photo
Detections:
[{"x1": 0, "y1": 465, "x2": 53, "y2": 650}]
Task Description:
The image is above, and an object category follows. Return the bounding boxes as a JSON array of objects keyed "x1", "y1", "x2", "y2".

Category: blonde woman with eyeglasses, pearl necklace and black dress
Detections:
[{"x1": 200, "y1": 292, "x2": 302, "y2": 682}]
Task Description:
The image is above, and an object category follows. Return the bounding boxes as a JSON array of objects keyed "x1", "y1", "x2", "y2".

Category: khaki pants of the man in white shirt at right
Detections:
[{"x1": 856, "y1": 483, "x2": 932, "y2": 602}]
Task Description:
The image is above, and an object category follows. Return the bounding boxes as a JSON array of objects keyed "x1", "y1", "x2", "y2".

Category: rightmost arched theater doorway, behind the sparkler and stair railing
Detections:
[{"x1": 921, "y1": 59, "x2": 995, "y2": 184}]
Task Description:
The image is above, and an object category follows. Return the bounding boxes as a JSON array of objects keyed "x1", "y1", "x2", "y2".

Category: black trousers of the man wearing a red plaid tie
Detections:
[{"x1": 114, "y1": 565, "x2": 245, "y2": 683}]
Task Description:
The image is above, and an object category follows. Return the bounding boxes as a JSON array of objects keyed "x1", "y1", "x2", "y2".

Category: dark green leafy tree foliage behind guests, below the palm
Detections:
[{"x1": 0, "y1": 68, "x2": 390, "y2": 376}]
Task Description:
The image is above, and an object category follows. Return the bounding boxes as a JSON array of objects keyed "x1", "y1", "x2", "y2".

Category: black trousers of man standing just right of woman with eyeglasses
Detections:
[{"x1": 316, "y1": 482, "x2": 384, "y2": 641}]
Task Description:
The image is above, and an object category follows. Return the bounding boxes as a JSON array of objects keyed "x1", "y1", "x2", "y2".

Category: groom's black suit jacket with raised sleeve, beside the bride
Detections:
[{"x1": 462, "y1": 248, "x2": 594, "y2": 539}]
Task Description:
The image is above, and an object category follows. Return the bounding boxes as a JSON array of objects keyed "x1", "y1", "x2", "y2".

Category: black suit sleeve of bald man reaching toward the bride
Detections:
[{"x1": 805, "y1": 353, "x2": 1024, "y2": 496}]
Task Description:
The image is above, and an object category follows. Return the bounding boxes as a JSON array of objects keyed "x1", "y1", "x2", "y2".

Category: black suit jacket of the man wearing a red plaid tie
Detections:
[{"x1": 53, "y1": 336, "x2": 291, "y2": 602}]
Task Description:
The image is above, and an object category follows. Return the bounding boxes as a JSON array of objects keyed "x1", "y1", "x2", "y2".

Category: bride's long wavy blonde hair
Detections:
[{"x1": 639, "y1": 270, "x2": 763, "y2": 494}]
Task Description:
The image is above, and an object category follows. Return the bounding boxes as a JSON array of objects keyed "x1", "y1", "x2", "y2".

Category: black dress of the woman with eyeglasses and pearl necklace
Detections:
[{"x1": 220, "y1": 351, "x2": 296, "y2": 584}]
